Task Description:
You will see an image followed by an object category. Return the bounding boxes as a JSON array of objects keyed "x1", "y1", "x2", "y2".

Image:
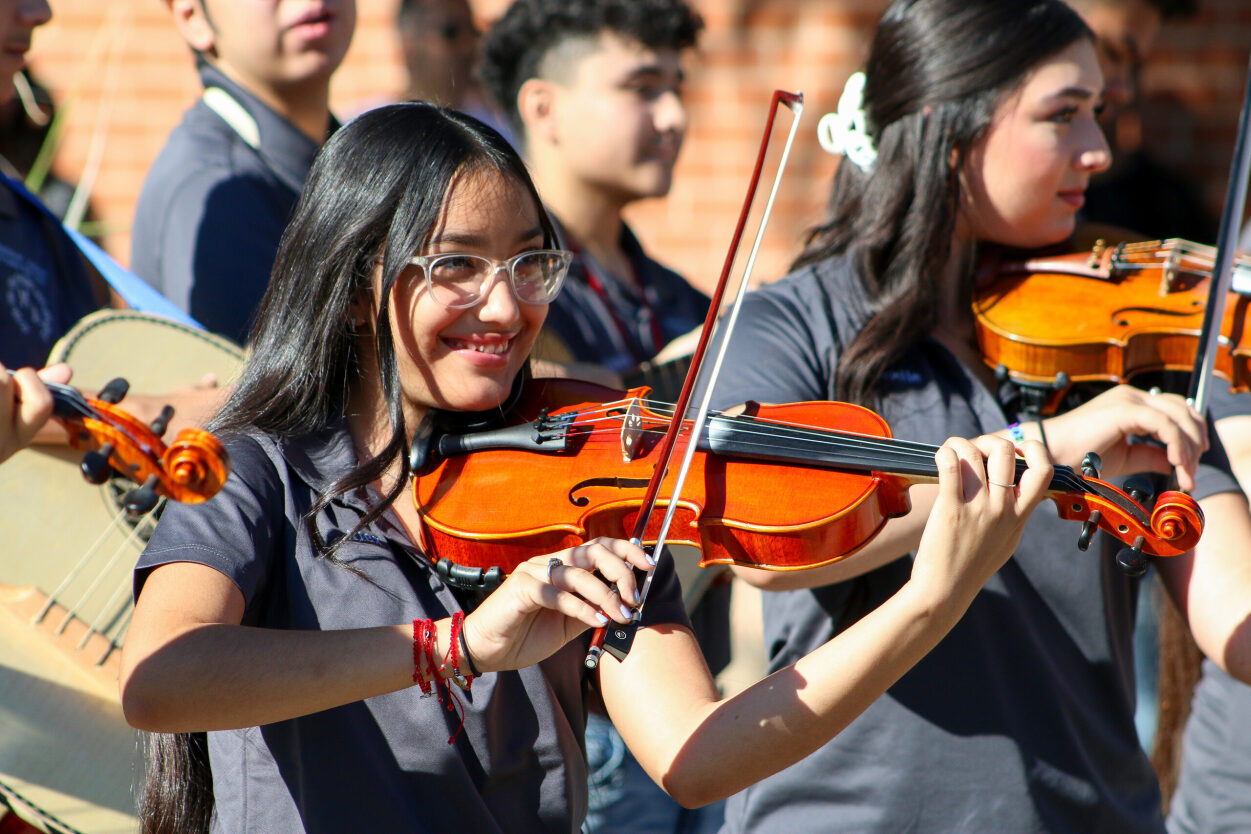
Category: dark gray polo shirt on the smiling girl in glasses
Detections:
[{"x1": 135, "y1": 430, "x2": 686, "y2": 834}]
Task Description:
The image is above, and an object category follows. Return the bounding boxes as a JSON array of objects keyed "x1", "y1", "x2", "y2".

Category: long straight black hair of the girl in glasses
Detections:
[{"x1": 139, "y1": 103, "x2": 555, "y2": 834}]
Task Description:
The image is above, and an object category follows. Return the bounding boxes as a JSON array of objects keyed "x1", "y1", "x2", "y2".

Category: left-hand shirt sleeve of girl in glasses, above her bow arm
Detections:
[{"x1": 134, "y1": 438, "x2": 286, "y2": 609}]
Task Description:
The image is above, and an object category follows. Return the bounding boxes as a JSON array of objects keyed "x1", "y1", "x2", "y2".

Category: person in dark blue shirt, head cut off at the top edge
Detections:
[{"x1": 130, "y1": 0, "x2": 355, "y2": 344}]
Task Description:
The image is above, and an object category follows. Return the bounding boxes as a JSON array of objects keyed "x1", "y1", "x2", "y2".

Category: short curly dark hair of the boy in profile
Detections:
[{"x1": 478, "y1": 0, "x2": 703, "y2": 133}]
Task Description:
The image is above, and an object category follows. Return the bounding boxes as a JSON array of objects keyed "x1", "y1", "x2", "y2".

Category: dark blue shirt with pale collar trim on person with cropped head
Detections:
[{"x1": 130, "y1": 63, "x2": 337, "y2": 344}]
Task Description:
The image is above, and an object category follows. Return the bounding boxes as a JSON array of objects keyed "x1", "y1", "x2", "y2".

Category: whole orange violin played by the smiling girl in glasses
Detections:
[{"x1": 413, "y1": 380, "x2": 1203, "y2": 589}]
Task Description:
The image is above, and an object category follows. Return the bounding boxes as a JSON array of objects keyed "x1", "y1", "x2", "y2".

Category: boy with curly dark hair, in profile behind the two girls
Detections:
[{"x1": 480, "y1": 6, "x2": 728, "y2": 834}]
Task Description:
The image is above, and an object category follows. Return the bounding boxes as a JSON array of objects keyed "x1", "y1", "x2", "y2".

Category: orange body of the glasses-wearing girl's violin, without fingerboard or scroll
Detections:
[{"x1": 413, "y1": 379, "x2": 911, "y2": 573}]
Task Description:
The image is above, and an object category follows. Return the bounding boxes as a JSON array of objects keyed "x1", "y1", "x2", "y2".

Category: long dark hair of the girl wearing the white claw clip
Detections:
[{"x1": 794, "y1": 0, "x2": 1093, "y2": 406}]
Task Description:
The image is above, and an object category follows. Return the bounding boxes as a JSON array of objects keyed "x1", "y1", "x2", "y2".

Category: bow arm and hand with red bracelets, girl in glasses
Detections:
[{"x1": 120, "y1": 539, "x2": 649, "y2": 733}]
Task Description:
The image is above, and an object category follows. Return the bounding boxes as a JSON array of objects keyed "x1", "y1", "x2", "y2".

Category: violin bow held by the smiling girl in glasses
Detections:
[{"x1": 585, "y1": 90, "x2": 803, "y2": 669}]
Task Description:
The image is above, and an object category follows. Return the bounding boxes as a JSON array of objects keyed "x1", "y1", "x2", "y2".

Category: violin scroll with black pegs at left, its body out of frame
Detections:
[{"x1": 35, "y1": 379, "x2": 230, "y2": 515}]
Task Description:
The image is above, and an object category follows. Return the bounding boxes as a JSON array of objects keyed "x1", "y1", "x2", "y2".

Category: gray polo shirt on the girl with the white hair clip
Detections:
[{"x1": 714, "y1": 259, "x2": 1236, "y2": 834}]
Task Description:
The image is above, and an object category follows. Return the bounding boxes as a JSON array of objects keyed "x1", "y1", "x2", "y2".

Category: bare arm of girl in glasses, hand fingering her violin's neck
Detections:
[{"x1": 599, "y1": 438, "x2": 1051, "y2": 806}]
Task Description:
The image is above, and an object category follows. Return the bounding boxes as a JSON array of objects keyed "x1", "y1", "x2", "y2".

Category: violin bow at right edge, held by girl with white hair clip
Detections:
[{"x1": 1187, "y1": 55, "x2": 1251, "y2": 415}]
